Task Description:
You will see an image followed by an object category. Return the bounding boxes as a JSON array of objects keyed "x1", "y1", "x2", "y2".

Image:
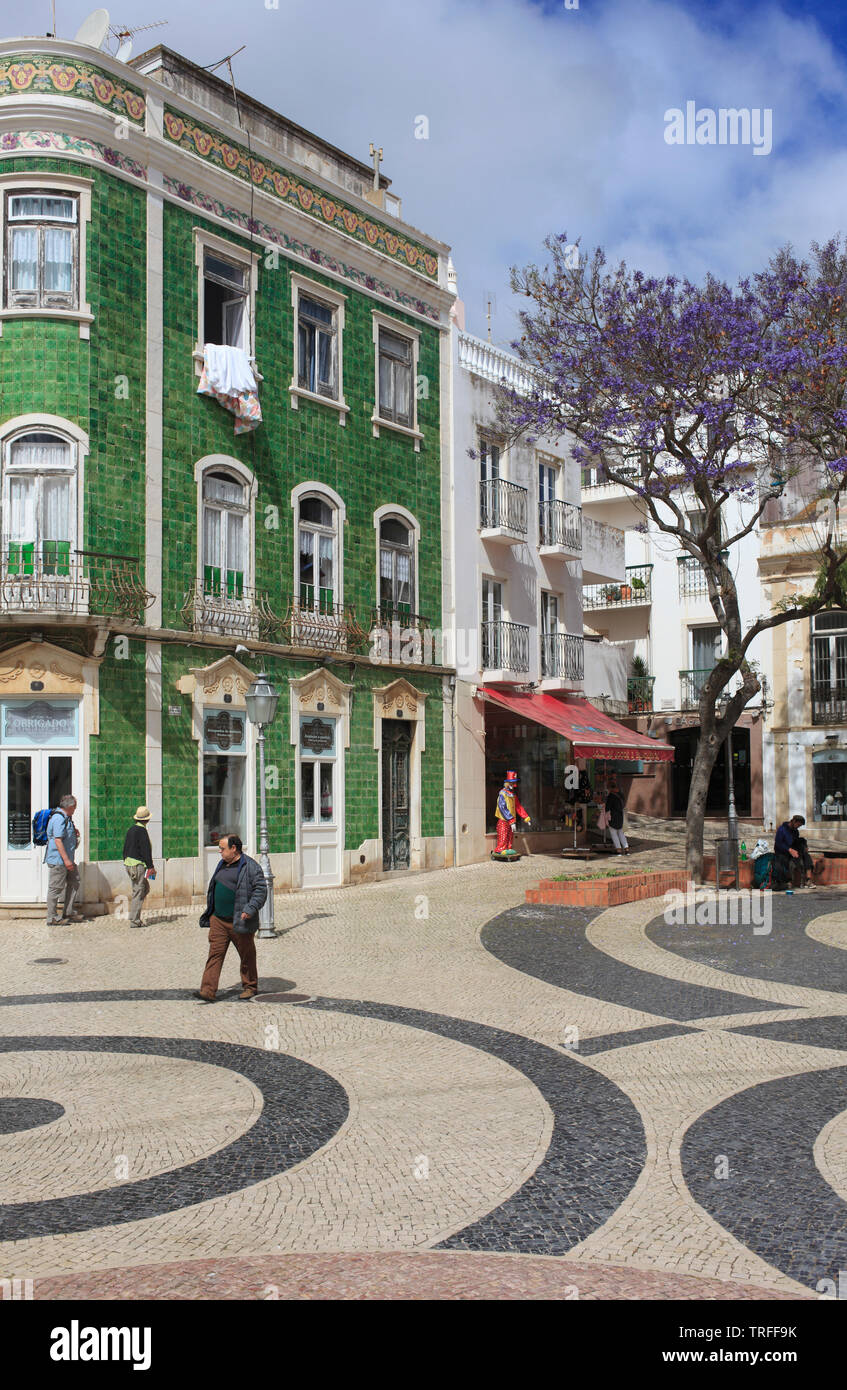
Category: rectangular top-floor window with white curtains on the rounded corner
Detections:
[{"x1": 4, "y1": 192, "x2": 79, "y2": 309}]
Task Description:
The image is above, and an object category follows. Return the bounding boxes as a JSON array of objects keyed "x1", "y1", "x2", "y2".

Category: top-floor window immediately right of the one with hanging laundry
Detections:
[{"x1": 289, "y1": 274, "x2": 349, "y2": 425}]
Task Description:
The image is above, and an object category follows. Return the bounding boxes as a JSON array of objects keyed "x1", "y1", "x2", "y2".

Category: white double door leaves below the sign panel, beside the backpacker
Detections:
[{"x1": 0, "y1": 748, "x2": 79, "y2": 904}]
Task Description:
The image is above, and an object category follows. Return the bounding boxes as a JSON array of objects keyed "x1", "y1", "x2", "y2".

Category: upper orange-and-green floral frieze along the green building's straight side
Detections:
[{"x1": 164, "y1": 110, "x2": 438, "y2": 279}]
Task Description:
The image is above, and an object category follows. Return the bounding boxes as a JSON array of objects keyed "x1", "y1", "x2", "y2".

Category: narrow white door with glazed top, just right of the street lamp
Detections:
[{"x1": 298, "y1": 714, "x2": 337, "y2": 888}]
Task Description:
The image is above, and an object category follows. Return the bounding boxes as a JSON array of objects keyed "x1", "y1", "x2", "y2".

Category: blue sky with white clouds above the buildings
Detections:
[{"x1": 0, "y1": 0, "x2": 847, "y2": 343}]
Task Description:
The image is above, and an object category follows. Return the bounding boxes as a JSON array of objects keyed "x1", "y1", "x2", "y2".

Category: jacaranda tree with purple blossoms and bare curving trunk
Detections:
[{"x1": 499, "y1": 235, "x2": 847, "y2": 881}]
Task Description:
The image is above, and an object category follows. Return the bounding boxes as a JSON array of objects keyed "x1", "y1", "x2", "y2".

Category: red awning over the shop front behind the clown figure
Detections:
[{"x1": 484, "y1": 687, "x2": 673, "y2": 763}]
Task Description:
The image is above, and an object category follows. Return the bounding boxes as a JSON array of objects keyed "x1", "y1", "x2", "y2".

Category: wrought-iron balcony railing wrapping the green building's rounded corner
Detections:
[{"x1": 0, "y1": 541, "x2": 153, "y2": 623}]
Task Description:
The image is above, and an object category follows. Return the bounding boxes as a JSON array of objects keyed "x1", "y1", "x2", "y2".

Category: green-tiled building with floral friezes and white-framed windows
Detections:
[{"x1": 0, "y1": 39, "x2": 455, "y2": 904}]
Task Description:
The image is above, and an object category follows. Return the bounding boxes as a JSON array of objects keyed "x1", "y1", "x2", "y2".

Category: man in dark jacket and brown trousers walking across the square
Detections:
[{"x1": 196, "y1": 835, "x2": 267, "y2": 1004}]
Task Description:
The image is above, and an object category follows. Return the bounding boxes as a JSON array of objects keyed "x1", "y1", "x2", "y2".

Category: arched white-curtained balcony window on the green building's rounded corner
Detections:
[{"x1": 3, "y1": 431, "x2": 76, "y2": 575}]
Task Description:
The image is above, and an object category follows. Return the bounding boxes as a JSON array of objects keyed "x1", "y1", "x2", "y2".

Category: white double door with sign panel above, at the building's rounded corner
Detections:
[{"x1": 0, "y1": 701, "x2": 82, "y2": 904}]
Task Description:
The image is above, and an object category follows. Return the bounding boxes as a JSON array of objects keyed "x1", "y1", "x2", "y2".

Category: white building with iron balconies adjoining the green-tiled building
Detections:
[{"x1": 442, "y1": 283, "x2": 627, "y2": 863}]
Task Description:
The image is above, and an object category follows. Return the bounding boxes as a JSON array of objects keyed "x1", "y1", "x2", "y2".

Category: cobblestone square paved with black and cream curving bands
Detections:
[{"x1": 0, "y1": 835, "x2": 847, "y2": 1300}]
